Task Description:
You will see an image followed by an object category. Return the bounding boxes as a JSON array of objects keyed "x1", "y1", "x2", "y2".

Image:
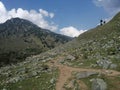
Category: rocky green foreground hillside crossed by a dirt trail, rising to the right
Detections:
[{"x1": 0, "y1": 13, "x2": 120, "y2": 90}]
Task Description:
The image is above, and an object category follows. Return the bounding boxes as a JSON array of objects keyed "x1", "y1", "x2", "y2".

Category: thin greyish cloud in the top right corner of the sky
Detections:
[{"x1": 93, "y1": 0, "x2": 120, "y2": 14}]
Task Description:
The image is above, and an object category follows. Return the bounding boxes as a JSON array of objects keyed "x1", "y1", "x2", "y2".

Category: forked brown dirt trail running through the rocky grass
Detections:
[{"x1": 47, "y1": 60, "x2": 120, "y2": 90}]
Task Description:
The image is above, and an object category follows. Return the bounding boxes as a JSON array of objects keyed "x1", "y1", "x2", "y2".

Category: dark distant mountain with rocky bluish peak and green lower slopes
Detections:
[{"x1": 0, "y1": 18, "x2": 72, "y2": 65}]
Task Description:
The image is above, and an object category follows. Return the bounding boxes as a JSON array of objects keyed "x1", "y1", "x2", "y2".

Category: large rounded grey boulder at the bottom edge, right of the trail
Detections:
[{"x1": 90, "y1": 78, "x2": 107, "y2": 90}]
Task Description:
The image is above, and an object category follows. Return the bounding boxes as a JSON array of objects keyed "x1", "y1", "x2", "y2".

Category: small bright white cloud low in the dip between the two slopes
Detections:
[{"x1": 60, "y1": 26, "x2": 86, "y2": 37}]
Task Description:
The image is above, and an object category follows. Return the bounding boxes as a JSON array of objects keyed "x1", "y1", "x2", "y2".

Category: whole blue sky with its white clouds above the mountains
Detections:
[{"x1": 0, "y1": 0, "x2": 120, "y2": 37}]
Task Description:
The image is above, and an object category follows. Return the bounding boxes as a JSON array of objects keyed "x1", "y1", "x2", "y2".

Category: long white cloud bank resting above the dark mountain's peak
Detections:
[{"x1": 0, "y1": 1, "x2": 57, "y2": 31}]
